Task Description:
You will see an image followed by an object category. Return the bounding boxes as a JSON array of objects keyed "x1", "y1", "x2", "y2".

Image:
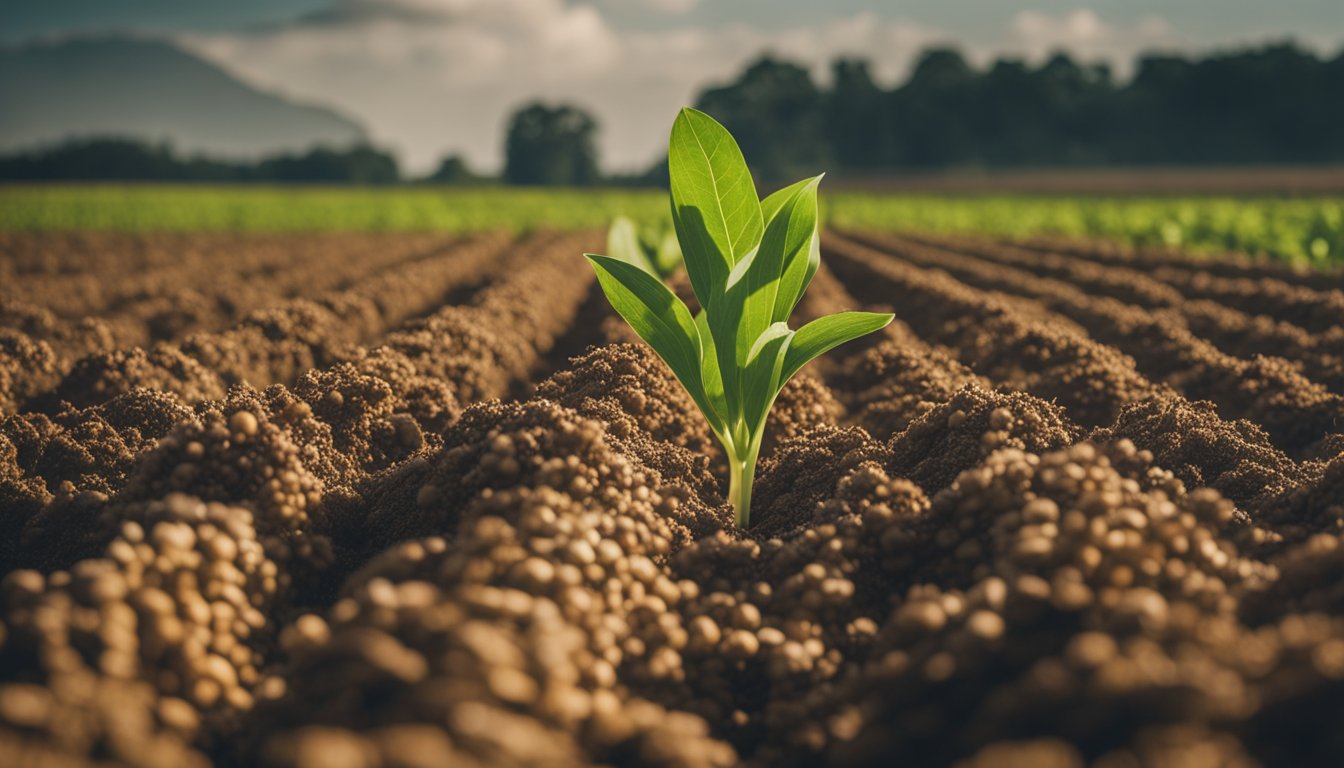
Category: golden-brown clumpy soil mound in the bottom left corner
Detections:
[{"x1": 0, "y1": 495, "x2": 288, "y2": 767}]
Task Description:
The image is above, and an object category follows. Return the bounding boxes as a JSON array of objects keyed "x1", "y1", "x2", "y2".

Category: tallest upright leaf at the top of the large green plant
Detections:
[{"x1": 668, "y1": 109, "x2": 765, "y2": 307}]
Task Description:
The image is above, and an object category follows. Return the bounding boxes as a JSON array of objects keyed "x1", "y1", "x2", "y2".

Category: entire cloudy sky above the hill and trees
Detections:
[{"x1": 10, "y1": 0, "x2": 1344, "y2": 171}]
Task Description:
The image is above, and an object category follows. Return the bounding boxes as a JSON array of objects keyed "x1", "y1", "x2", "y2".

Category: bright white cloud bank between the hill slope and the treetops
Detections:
[{"x1": 181, "y1": 0, "x2": 1169, "y2": 171}]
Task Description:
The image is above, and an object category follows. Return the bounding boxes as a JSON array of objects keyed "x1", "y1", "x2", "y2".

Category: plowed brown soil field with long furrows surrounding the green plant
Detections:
[{"x1": 0, "y1": 231, "x2": 1344, "y2": 768}]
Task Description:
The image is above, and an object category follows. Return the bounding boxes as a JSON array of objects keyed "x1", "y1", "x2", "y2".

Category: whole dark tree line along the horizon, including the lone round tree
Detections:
[{"x1": 0, "y1": 43, "x2": 1344, "y2": 186}]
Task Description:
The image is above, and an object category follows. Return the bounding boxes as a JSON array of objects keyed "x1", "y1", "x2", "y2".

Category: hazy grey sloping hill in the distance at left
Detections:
[{"x1": 0, "y1": 38, "x2": 367, "y2": 157}]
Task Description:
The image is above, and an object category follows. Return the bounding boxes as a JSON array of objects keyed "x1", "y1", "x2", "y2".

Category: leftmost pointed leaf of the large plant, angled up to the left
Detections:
[{"x1": 586, "y1": 253, "x2": 714, "y2": 430}]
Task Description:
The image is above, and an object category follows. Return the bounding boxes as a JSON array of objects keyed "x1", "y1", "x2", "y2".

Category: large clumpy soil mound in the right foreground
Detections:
[{"x1": 828, "y1": 444, "x2": 1269, "y2": 764}]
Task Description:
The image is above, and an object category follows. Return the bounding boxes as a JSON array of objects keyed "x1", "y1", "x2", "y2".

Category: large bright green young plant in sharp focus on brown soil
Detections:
[{"x1": 587, "y1": 109, "x2": 892, "y2": 526}]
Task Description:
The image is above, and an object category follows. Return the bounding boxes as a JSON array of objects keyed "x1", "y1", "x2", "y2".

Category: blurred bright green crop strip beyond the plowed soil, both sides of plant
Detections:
[{"x1": 0, "y1": 184, "x2": 1344, "y2": 265}]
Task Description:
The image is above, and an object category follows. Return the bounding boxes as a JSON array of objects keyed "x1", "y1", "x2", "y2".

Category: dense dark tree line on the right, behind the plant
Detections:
[{"x1": 698, "y1": 43, "x2": 1344, "y2": 179}]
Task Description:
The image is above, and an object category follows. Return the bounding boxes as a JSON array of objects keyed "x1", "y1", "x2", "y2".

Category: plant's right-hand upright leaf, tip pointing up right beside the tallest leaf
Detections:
[{"x1": 727, "y1": 176, "x2": 821, "y2": 363}]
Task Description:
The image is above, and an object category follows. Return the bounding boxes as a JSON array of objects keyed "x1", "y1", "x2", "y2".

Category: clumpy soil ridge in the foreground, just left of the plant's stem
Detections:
[{"x1": 249, "y1": 385, "x2": 734, "y2": 765}]
